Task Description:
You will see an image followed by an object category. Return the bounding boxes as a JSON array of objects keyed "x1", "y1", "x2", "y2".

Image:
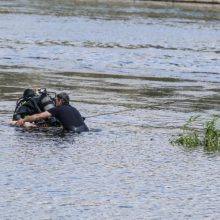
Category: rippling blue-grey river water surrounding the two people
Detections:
[{"x1": 0, "y1": 0, "x2": 220, "y2": 220}]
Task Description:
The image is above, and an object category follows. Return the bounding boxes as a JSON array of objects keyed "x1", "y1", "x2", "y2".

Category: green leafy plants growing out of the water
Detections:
[{"x1": 171, "y1": 116, "x2": 220, "y2": 152}]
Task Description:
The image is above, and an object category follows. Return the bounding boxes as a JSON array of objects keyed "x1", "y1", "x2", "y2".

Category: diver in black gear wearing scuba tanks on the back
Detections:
[{"x1": 13, "y1": 89, "x2": 60, "y2": 126}]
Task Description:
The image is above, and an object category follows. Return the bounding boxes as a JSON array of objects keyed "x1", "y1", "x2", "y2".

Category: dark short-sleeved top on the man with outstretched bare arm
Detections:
[{"x1": 48, "y1": 104, "x2": 89, "y2": 133}]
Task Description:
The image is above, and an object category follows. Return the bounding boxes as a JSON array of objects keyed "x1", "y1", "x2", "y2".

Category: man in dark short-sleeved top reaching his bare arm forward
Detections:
[{"x1": 16, "y1": 92, "x2": 89, "y2": 133}]
